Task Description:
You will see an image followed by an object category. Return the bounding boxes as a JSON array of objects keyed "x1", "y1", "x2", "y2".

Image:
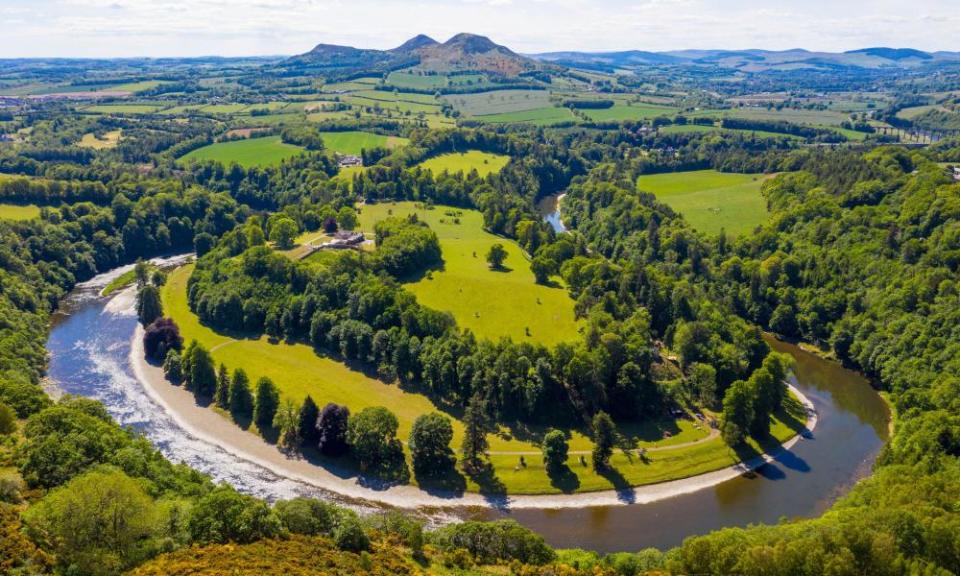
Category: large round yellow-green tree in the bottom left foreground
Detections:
[{"x1": 24, "y1": 469, "x2": 158, "y2": 574}]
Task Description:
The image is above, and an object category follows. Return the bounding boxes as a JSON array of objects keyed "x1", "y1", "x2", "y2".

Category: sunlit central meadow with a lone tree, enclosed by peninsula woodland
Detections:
[{"x1": 360, "y1": 202, "x2": 579, "y2": 346}]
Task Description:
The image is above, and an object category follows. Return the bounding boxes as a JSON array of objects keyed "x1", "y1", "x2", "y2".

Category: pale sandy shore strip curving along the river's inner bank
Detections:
[{"x1": 130, "y1": 325, "x2": 817, "y2": 509}]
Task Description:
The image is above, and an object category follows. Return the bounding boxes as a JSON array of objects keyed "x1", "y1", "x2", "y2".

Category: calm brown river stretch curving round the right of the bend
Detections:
[{"x1": 467, "y1": 339, "x2": 890, "y2": 552}]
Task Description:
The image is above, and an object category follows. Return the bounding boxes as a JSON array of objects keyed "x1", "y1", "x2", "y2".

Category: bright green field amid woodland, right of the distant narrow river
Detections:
[{"x1": 637, "y1": 170, "x2": 767, "y2": 235}]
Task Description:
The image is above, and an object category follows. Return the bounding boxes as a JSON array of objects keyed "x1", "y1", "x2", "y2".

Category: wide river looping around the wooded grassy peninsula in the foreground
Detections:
[{"x1": 47, "y1": 262, "x2": 889, "y2": 551}]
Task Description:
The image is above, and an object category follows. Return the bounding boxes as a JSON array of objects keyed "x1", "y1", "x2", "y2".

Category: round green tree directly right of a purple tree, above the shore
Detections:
[{"x1": 347, "y1": 406, "x2": 403, "y2": 472}]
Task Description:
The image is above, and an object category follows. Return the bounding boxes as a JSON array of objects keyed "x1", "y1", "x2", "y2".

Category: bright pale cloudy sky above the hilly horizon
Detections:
[{"x1": 0, "y1": 0, "x2": 960, "y2": 58}]
